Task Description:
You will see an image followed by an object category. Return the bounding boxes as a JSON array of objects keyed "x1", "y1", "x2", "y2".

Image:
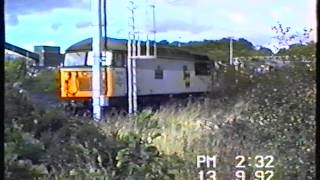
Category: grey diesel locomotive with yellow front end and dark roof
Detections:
[{"x1": 58, "y1": 38, "x2": 213, "y2": 115}]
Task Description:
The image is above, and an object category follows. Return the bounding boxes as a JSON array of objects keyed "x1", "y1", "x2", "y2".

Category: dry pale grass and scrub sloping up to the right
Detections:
[{"x1": 103, "y1": 63, "x2": 315, "y2": 180}]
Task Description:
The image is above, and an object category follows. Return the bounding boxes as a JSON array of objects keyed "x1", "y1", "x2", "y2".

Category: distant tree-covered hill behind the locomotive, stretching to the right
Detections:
[{"x1": 159, "y1": 38, "x2": 316, "y2": 62}]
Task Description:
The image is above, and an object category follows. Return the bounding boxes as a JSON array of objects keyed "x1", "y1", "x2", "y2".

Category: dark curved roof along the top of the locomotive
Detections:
[{"x1": 66, "y1": 38, "x2": 209, "y2": 60}]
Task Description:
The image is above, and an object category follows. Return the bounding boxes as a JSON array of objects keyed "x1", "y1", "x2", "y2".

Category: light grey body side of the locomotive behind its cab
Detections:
[{"x1": 137, "y1": 58, "x2": 211, "y2": 95}]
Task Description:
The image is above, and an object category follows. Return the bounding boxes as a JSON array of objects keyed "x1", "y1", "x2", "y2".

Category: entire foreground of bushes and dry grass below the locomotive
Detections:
[{"x1": 5, "y1": 59, "x2": 315, "y2": 179}]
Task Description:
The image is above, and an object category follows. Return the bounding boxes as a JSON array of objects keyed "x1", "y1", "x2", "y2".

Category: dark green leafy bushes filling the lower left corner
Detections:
[{"x1": 4, "y1": 60, "x2": 175, "y2": 179}]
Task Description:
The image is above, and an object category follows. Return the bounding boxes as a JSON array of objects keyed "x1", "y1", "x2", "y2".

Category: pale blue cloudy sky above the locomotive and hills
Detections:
[{"x1": 5, "y1": 0, "x2": 317, "y2": 53}]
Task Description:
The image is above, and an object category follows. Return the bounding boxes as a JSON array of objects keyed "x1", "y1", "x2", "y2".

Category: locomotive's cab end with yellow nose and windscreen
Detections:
[{"x1": 57, "y1": 39, "x2": 127, "y2": 109}]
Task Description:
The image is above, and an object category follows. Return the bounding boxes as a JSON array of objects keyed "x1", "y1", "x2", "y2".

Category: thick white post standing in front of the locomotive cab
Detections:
[{"x1": 91, "y1": 0, "x2": 102, "y2": 121}]
